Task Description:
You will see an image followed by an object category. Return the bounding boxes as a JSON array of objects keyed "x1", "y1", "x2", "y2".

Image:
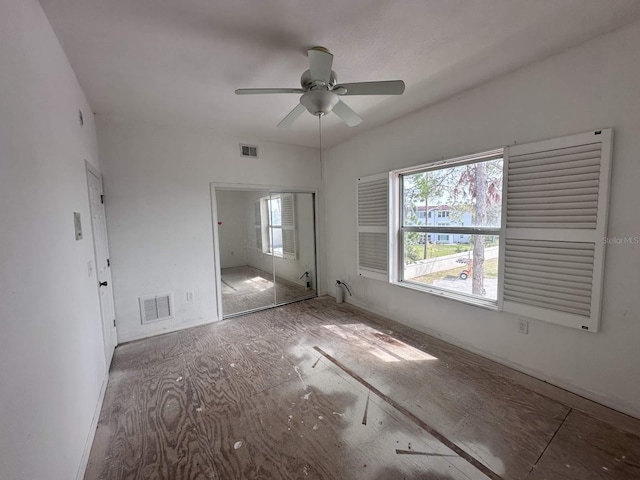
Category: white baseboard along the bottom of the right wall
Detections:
[{"x1": 345, "y1": 298, "x2": 640, "y2": 419}]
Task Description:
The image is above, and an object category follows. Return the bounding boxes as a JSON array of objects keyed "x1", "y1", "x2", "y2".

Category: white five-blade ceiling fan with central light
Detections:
[{"x1": 236, "y1": 47, "x2": 404, "y2": 128}]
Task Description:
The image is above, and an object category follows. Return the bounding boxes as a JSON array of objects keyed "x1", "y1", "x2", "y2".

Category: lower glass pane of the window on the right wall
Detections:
[{"x1": 403, "y1": 232, "x2": 499, "y2": 300}]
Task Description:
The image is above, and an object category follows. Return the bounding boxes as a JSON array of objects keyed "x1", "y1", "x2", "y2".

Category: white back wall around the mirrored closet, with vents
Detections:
[{"x1": 96, "y1": 115, "x2": 320, "y2": 342}]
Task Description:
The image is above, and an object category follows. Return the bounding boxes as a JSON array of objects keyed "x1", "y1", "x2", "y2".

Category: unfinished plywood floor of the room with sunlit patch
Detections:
[{"x1": 85, "y1": 297, "x2": 640, "y2": 480}]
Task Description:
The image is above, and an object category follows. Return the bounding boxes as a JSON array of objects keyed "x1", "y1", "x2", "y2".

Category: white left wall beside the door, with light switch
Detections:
[{"x1": 0, "y1": 0, "x2": 106, "y2": 480}]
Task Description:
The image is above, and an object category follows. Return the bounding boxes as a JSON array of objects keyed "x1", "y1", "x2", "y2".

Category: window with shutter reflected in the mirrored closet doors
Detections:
[{"x1": 256, "y1": 193, "x2": 296, "y2": 260}]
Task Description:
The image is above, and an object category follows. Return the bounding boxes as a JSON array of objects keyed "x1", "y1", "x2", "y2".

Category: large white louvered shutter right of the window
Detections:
[{"x1": 502, "y1": 130, "x2": 612, "y2": 332}]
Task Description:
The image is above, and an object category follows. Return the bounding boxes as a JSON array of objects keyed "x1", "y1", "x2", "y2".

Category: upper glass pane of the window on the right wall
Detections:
[{"x1": 401, "y1": 159, "x2": 503, "y2": 227}]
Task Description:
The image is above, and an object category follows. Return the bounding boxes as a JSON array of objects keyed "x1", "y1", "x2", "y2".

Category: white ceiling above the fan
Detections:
[{"x1": 40, "y1": 0, "x2": 640, "y2": 147}]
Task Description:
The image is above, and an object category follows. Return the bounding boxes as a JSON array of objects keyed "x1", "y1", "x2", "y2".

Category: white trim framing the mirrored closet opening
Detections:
[{"x1": 210, "y1": 182, "x2": 324, "y2": 320}]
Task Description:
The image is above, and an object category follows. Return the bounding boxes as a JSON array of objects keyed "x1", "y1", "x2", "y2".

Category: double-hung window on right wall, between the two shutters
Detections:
[{"x1": 397, "y1": 152, "x2": 503, "y2": 305}]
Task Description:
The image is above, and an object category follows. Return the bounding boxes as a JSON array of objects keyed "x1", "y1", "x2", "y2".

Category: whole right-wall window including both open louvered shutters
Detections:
[{"x1": 357, "y1": 130, "x2": 613, "y2": 332}]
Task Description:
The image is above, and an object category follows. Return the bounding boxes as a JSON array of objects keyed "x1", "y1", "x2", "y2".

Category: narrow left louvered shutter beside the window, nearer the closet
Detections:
[{"x1": 357, "y1": 173, "x2": 389, "y2": 281}]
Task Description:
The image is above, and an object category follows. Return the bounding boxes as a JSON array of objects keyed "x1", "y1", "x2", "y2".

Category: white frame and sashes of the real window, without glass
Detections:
[{"x1": 389, "y1": 148, "x2": 506, "y2": 310}]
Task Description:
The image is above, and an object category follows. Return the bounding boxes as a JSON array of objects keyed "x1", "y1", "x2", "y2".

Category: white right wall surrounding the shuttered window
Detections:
[{"x1": 323, "y1": 23, "x2": 640, "y2": 417}]
